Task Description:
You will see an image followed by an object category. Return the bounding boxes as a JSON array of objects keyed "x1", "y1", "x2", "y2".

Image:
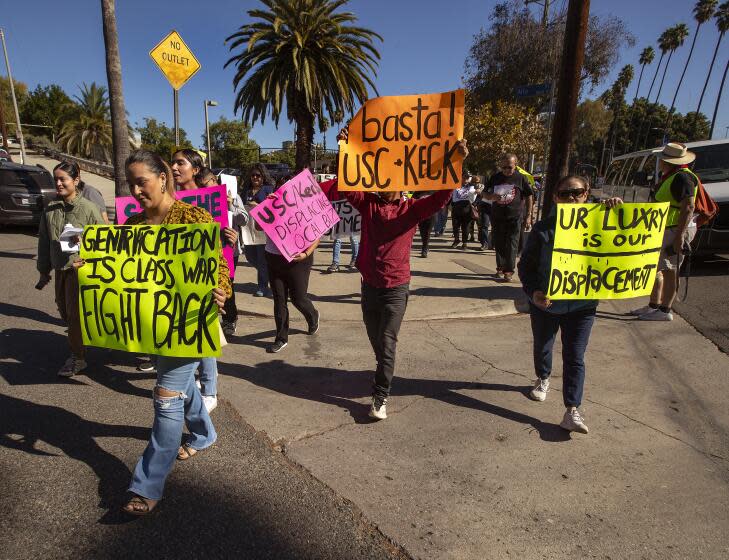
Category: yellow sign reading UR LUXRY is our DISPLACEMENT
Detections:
[{"x1": 547, "y1": 202, "x2": 668, "y2": 300}]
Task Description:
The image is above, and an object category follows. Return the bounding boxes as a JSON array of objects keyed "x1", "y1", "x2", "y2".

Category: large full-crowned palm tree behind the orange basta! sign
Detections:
[{"x1": 225, "y1": 0, "x2": 382, "y2": 169}]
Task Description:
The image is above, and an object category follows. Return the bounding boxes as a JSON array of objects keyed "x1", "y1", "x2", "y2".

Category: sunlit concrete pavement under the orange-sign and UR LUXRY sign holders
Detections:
[{"x1": 219, "y1": 238, "x2": 729, "y2": 559}]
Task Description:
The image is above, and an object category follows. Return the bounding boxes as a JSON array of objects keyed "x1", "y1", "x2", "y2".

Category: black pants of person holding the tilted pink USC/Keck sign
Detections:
[{"x1": 266, "y1": 251, "x2": 318, "y2": 342}]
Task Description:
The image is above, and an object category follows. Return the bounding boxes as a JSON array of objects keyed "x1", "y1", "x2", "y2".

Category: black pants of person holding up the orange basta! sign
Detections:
[{"x1": 362, "y1": 283, "x2": 410, "y2": 398}]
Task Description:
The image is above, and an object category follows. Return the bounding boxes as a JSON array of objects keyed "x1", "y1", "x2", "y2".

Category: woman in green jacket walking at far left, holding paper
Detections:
[{"x1": 36, "y1": 162, "x2": 104, "y2": 377}]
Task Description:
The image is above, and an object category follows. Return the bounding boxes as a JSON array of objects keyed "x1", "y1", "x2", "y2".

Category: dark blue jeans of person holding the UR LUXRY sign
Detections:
[{"x1": 529, "y1": 304, "x2": 596, "y2": 407}]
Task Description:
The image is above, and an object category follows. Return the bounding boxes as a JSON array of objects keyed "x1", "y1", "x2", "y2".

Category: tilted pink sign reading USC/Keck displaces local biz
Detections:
[{"x1": 250, "y1": 169, "x2": 339, "y2": 262}]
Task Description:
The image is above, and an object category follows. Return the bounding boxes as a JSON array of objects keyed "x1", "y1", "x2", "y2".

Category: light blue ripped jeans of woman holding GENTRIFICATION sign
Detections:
[{"x1": 129, "y1": 356, "x2": 218, "y2": 500}]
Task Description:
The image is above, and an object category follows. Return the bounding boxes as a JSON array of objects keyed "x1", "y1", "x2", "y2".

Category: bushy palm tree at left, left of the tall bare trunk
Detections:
[{"x1": 58, "y1": 83, "x2": 113, "y2": 161}]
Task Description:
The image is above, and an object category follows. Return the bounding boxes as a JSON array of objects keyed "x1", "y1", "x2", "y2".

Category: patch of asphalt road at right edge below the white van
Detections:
[{"x1": 674, "y1": 255, "x2": 729, "y2": 354}]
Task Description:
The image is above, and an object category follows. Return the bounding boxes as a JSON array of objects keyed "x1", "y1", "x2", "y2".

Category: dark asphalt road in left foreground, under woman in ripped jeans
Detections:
[{"x1": 0, "y1": 225, "x2": 409, "y2": 560}]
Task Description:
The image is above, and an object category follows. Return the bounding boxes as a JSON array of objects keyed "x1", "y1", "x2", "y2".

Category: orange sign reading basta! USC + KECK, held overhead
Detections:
[{"x1": 338, "y1": 89, "x2": 465, "y2": 191}]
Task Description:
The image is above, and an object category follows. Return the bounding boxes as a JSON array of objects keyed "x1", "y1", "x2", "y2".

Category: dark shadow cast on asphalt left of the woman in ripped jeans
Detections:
[{"x1": 0, "y1": 395, "x2": 149, "y2": 507}]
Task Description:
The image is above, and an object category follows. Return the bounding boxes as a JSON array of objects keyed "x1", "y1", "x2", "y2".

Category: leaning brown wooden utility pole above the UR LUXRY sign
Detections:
[{"x1": 543, "y1": 0, "x2": 590, "y2": 216}]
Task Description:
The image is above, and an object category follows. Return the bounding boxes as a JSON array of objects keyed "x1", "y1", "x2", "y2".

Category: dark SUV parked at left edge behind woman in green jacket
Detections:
[{"x1": 0, "y1": 161, "x2": 56, "y2": 225}]
